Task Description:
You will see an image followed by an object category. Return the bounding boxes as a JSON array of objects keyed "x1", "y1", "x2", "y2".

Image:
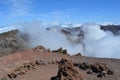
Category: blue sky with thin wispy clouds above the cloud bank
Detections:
[{"x1": 0, "y1": 0, "x2": 120, "y2": 26}]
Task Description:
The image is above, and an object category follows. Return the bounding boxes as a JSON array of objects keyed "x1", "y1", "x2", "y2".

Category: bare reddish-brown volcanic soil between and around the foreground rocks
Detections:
[{"x1": 0, "y1": 49, "x2": 120, "y2": 80}]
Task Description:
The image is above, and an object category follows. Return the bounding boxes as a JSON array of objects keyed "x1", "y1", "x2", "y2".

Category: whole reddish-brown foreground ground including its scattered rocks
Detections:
[{"x1": 0, "y1": 46, "x2": 120, "y2": 80}]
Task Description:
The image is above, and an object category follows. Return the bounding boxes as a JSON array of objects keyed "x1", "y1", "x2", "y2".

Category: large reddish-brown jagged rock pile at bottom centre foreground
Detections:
[{"x1": 51, "y1": 58, "x2": 83, "y2": 80}]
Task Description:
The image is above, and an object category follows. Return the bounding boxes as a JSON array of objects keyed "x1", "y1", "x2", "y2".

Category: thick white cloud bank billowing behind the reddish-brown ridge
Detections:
[{"x1": 0, "y1": 21, "x2": 120, "y2": 58}]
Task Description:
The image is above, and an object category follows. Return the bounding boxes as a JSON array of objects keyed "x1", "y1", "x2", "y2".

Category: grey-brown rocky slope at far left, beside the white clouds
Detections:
[{"x1": 0, "y1": 30, "x2": 28, "y2": 56}]
